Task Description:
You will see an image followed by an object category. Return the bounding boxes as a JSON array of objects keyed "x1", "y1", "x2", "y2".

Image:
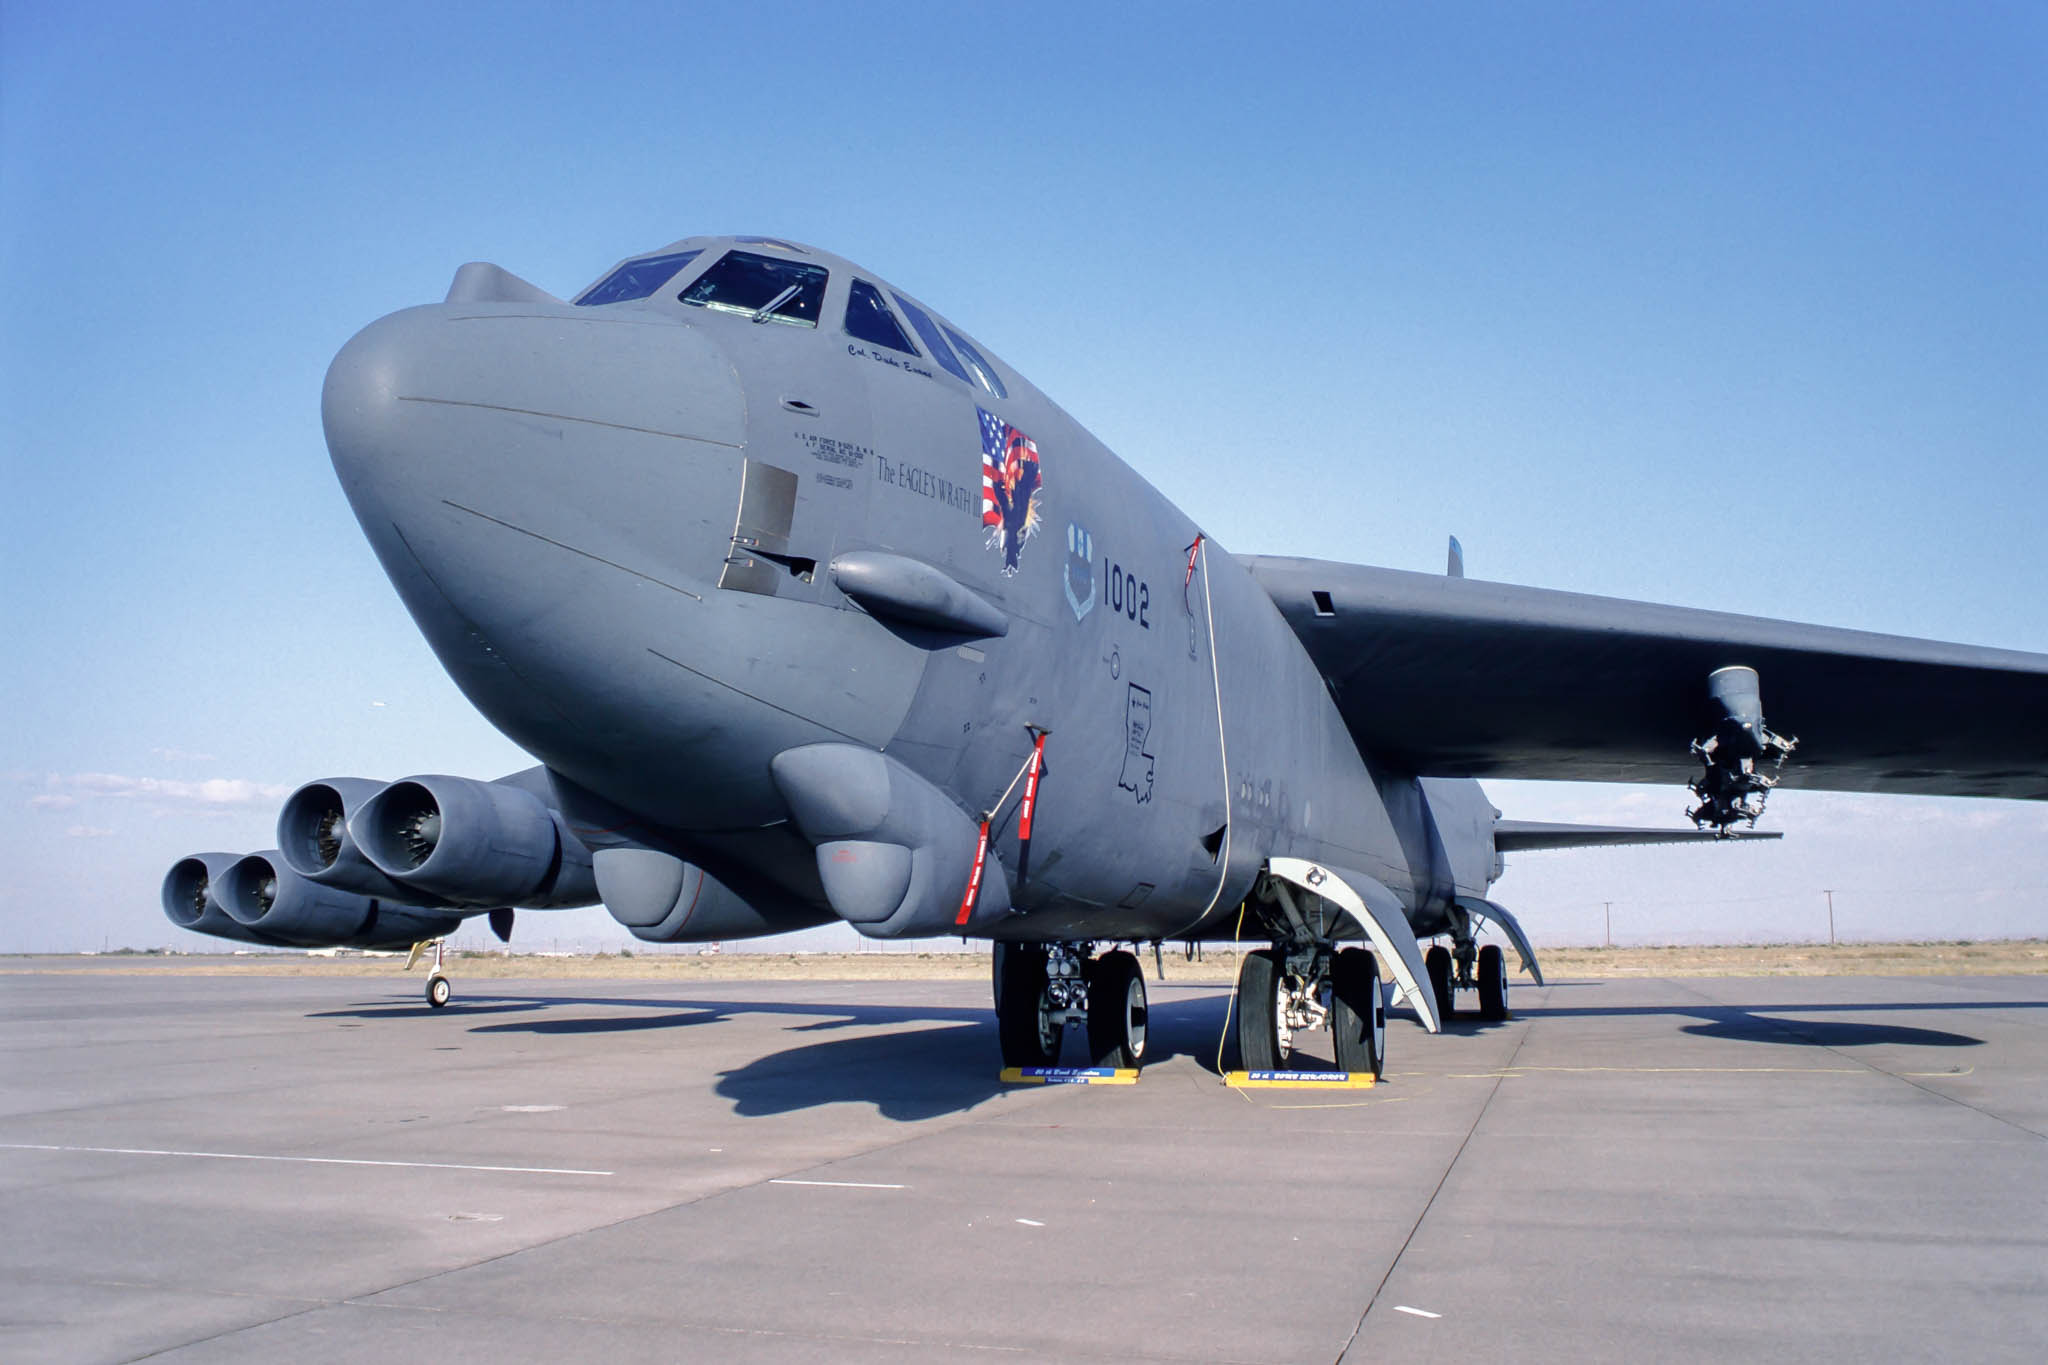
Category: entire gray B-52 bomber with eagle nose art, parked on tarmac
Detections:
[{"x1": 164, "y1": 237, "x2": 2048, "y2": 1074}]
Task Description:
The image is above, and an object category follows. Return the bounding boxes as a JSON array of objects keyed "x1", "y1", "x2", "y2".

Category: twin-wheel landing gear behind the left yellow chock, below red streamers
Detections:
[{"x1": 995, "y1": 943, "x2": 1149, "y2": 1068}]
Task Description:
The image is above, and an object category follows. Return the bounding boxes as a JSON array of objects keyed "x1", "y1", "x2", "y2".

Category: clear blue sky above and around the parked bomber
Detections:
[{"x1": 0, "y1": 0, "x2": 2048, "y2": 950}]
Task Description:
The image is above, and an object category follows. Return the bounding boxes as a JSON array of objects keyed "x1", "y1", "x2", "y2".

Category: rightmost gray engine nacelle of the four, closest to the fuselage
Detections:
[{"x1": 348, "y1": 774, "x2": 598, "y2": 909}]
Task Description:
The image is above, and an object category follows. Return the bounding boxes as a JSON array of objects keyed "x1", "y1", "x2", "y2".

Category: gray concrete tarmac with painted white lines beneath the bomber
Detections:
[{"x1": 0, "y1": 964, "x2": 2048, "y2": 1365}]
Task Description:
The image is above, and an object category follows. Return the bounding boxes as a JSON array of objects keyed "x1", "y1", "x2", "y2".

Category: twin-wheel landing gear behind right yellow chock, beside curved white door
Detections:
[{"x1": 1235, "y1": 941, "x2": 1386, "y2": 1081}]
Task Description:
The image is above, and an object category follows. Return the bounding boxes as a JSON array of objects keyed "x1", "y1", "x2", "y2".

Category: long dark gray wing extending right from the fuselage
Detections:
[{"x1": 1245, "y1": 557, "x2": 2048, "y2": 800}]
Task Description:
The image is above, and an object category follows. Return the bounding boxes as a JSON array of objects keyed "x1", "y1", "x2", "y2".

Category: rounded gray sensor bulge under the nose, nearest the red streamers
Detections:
[{"x1": 768, "y1": 745, "x2": 1010, "y2": 939}]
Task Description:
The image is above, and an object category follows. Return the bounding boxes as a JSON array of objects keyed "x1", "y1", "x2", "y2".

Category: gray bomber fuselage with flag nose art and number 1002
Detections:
[{"x1": 324, "y1": 239, "x2": 1497, "y2": 939}]
